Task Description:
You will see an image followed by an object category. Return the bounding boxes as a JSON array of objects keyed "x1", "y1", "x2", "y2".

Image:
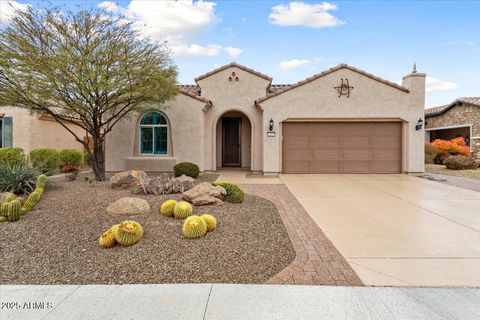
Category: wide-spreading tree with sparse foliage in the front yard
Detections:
[{"x1": 0, "y1": 7, "x2": 177, "y2": 180}]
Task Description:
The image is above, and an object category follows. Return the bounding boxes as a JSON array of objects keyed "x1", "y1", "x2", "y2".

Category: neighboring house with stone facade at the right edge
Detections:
[{"x1": 425, "y1": 97, "x2": 480, "y2": 157}]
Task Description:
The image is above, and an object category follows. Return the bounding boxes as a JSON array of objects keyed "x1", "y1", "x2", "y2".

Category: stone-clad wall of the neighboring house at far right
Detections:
[{"x1": 425, "y1": 104, "x2": 480, "y2": 158}]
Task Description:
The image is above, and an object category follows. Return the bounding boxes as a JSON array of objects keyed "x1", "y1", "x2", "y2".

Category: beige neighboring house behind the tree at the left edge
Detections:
[{"x1": 0, "y1": 107, "x2": 85, "y2": 154}]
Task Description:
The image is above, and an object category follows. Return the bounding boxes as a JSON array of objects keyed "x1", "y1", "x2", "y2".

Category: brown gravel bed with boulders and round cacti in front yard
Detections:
[{"x1": 0, "y1": 176, "x2": 295, "y2": 284}]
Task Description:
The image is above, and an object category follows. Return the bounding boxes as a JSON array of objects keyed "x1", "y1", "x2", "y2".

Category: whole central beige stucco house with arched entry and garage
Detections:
[{"x1": 106, "y1": 63, "x2": 425, "y2": 174}]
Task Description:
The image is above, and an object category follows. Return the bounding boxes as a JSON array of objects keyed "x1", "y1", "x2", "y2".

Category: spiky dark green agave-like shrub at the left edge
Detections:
[{"x1": 0, "y1": 162, "x2": 41, "y2": 194}]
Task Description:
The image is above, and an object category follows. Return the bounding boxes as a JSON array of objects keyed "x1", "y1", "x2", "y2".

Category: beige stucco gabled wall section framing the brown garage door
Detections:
[{"x1": 260, "y1": 69, "x2": 425, "y2": 173}]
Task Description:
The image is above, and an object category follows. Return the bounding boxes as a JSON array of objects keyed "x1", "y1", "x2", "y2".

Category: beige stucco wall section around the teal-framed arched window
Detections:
[{"x1": 105, "y1": 94, "x2": 205, "y2": 172}]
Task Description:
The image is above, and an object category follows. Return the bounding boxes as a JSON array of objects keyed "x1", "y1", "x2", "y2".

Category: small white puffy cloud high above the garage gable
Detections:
[{"x1": 268, "y1": 1, "x2": 345, "y2": 28}]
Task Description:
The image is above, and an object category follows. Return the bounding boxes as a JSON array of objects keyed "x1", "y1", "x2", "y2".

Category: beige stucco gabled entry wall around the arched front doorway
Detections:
[{"x1": 197, "y1": 67, "x2": 270, "y2": 171}]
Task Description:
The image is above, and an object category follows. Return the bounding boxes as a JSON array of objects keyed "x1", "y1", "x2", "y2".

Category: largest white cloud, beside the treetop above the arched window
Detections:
[{"x1": 98, "y1": 0, "x2": 242, "y2": 58}]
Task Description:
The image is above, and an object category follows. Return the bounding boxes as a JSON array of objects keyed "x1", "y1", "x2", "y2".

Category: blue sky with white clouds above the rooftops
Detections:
[{"x1": 0, "y1": 0, "x2": 480, "y2": 107}]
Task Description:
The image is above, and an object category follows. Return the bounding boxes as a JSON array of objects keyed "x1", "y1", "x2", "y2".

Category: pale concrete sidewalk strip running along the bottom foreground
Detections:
[{"x1": 0, "y1": 284, "x2": 480, "y2": 320}]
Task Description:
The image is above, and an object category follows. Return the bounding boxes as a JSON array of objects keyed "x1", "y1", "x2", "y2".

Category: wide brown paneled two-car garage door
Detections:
[{"x1": 282, "y1": 122, "x2": 402, "y2": 173}]
